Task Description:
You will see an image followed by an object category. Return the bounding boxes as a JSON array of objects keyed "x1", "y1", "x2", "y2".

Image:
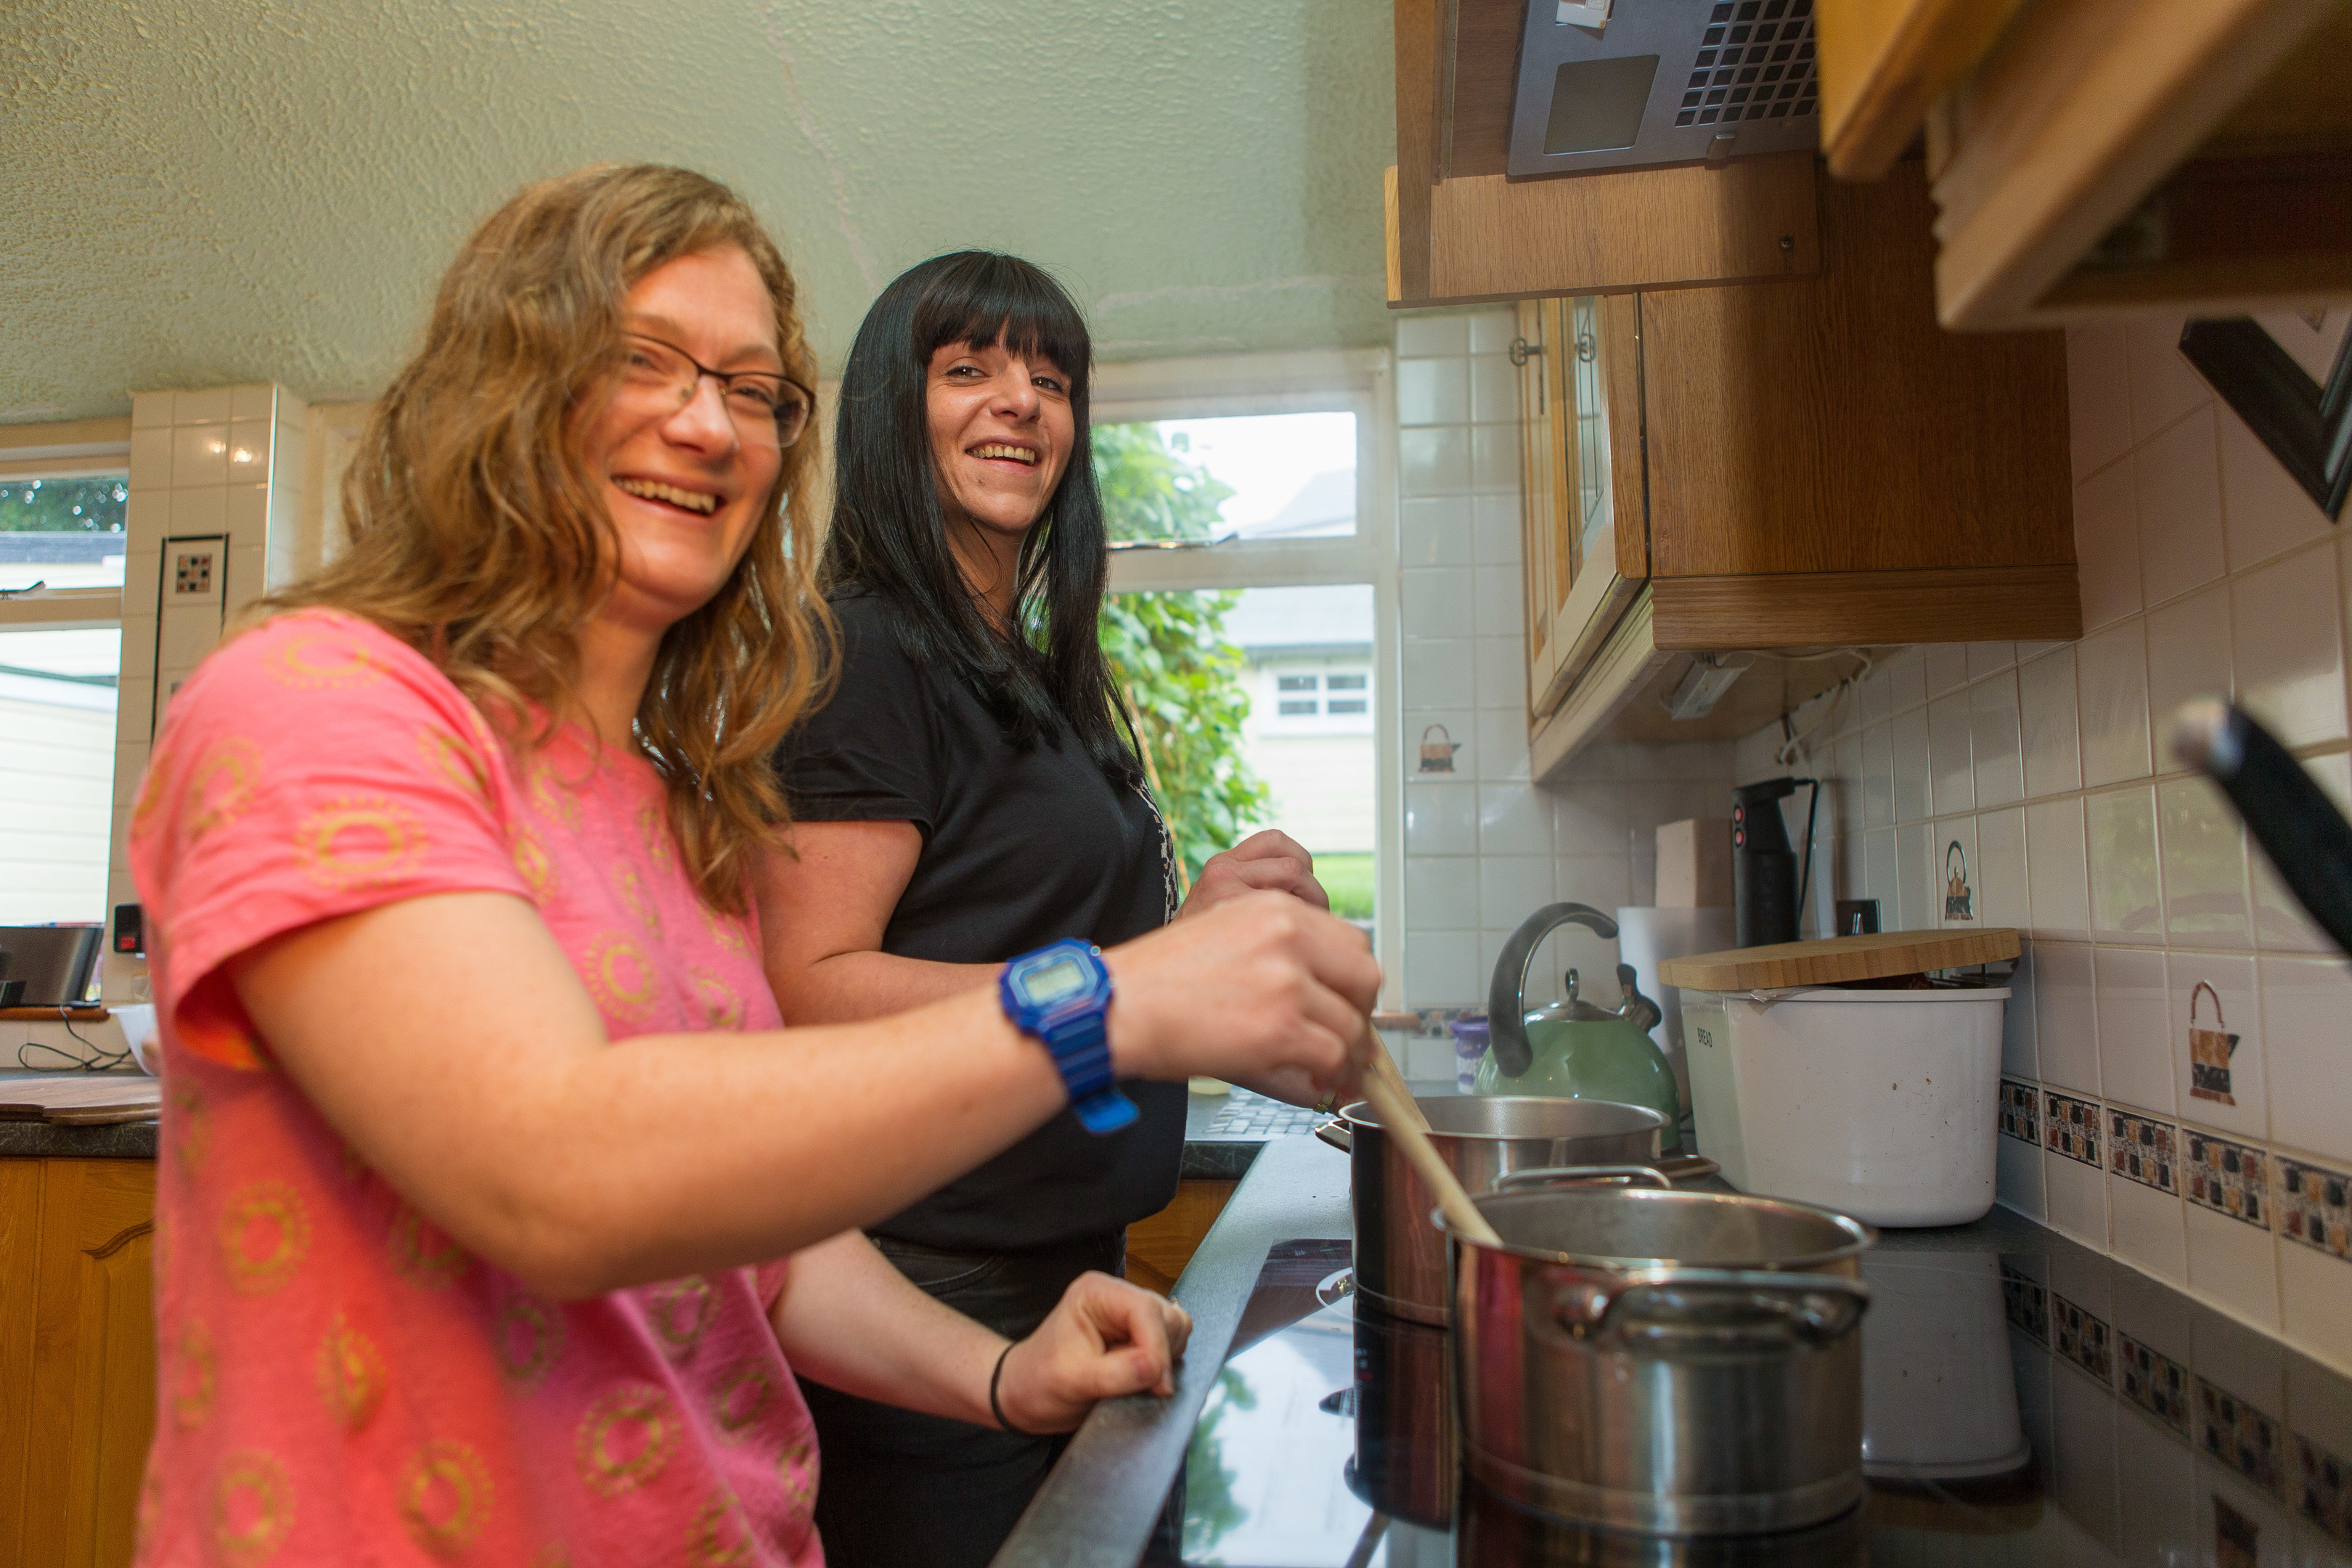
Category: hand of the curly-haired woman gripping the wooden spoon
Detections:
[{"x1": 1103, "y1": 894, "x2": 1381, "y2": 1088}]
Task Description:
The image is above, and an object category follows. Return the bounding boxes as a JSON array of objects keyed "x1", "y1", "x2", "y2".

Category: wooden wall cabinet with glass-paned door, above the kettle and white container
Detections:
[{"x1": 1517, "y1": 162, "x2": 2081, "y2": 778}]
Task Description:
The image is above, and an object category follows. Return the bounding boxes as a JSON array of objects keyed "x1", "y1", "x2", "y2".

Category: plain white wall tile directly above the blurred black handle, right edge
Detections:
[{"x1": 2230, "y1": 545, "x2": 2345, "y2": 746}]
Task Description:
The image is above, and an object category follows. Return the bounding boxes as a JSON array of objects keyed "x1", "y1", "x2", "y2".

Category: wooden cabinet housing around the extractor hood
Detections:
[{"x1": 1383, "y1": 0, "x2": 1821, "y2": 306}]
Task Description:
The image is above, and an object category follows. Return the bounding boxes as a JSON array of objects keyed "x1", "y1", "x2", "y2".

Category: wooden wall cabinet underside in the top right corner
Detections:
[{"x1": 1816, "y1": 0, "x2": 2352, "y2": 327}]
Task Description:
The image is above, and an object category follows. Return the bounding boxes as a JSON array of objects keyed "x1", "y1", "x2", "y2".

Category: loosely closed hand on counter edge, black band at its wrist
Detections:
[{"x1": 997, "y1": 1270, "x2": 1193, "y2": 1434}]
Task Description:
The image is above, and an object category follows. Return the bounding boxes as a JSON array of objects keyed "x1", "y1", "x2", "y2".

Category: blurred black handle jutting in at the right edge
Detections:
[{"x1": 2173, "y1": 698, "x2": 2352, "y2": 952}]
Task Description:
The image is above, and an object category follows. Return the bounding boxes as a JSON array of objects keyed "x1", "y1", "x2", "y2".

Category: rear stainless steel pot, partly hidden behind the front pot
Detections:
[{"x1": 1317, "y1": 1095, "x2": 1665, "y2": 1326}]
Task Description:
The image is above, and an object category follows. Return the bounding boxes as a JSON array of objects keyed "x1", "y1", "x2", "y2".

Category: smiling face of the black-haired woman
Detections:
[{"x1": 924, "y1": 343, "x2": 1077, "y2": 536}]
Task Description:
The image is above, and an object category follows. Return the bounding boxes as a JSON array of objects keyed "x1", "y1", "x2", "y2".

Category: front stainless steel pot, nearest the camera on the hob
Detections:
[{"x1": 1437, "y1": 1177, "x2": 1874, "y2": 1535}]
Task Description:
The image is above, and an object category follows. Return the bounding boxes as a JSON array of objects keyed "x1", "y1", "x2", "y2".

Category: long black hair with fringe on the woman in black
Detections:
[{"x1": 823, "y1": 252, "x2": 1140, "y2": 783}]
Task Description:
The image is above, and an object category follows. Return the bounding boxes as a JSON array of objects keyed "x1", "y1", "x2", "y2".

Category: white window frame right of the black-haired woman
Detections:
[{"x1": 1087, "y1": 348, "x2": 1404, "y2": 1006}]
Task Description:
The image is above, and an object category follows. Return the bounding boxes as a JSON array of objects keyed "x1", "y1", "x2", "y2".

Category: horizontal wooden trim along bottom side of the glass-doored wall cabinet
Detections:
[{"x1": 1649, "y1": 562, "x2": 2081, "y2": 649}]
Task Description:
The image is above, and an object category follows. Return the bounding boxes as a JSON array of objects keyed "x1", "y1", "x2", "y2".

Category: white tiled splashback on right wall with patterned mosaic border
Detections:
[{"x1": 1736, "y1": 319, "x2": 2352, "y2": 1371}]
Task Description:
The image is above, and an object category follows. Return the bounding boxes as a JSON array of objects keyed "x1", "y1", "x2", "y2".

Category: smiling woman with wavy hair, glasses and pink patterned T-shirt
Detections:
[{"x1": 131, "y1": 167, "x2": 1379, "y2": 1568}]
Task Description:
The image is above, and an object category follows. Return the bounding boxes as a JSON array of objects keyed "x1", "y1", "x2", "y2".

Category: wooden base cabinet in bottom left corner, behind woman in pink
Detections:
[{"x1": 0, "y1": 1159, "x2": 155, "y2": 1568}]
